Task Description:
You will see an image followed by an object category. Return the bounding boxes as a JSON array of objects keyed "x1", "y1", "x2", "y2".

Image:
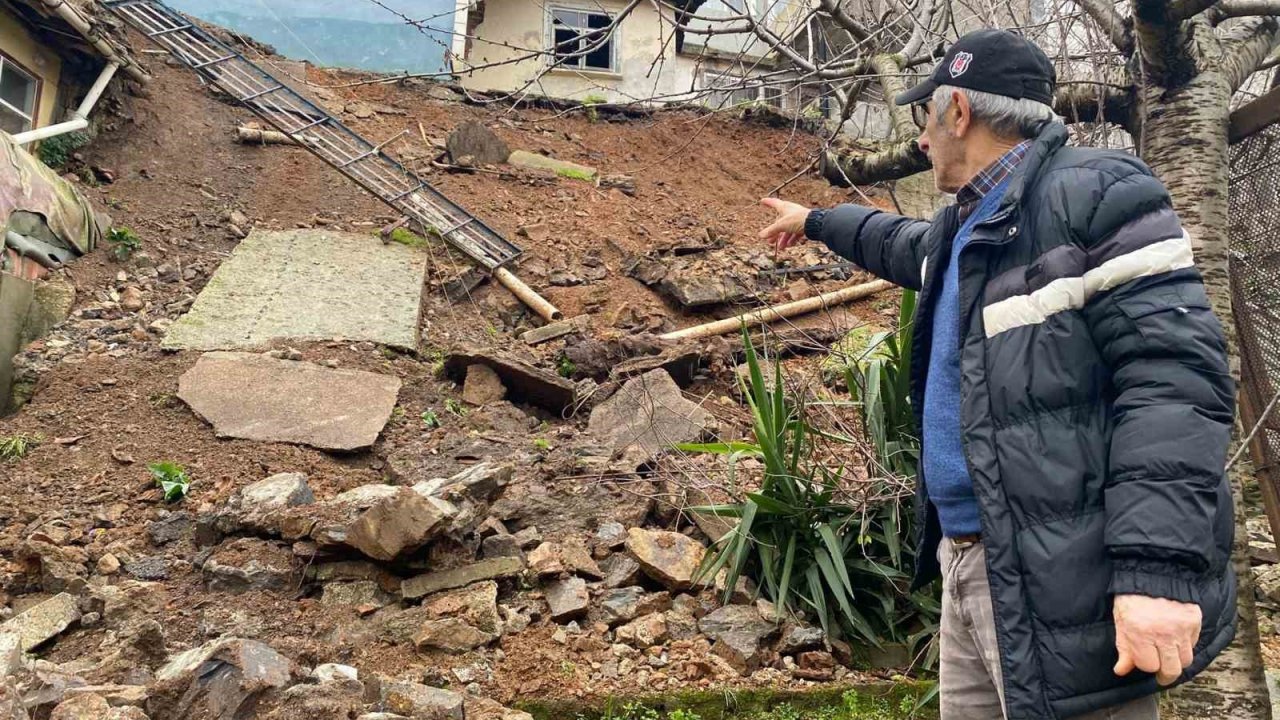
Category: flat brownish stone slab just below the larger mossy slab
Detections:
[{"x1": 178, "y1": 352, "x2": 401, "y2": 450}]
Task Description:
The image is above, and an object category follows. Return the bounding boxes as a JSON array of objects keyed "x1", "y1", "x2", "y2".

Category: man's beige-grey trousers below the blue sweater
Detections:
[{"x1": 938, "y1": 538, "x2": 1160, "y2": 720}]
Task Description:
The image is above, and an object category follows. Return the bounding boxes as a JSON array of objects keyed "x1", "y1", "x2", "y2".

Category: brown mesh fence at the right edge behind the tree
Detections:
[{"x1": 1229, "y1": 126, "x2": 1280, "y2": 504}]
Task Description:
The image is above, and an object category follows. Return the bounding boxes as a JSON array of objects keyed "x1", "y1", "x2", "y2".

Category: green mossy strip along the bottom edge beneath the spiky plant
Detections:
[{"x1": 516, "y1": 682, "x2": 937, "y2": 720}]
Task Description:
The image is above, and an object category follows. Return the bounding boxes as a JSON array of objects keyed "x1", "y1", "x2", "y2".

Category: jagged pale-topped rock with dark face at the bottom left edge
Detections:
[{"x1": 156, "y1": 638, "x2": 293, "y2": 720}]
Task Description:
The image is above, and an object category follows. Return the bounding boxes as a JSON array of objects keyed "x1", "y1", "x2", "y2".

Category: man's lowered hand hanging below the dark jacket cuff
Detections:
[{"x1": 1114, "y1": 594, "x2": 1201, "y2": 685}]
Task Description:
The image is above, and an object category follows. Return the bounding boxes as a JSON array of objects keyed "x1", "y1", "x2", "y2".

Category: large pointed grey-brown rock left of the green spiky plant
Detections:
[{"x1": 588, "y1": 369, "x2": 712, "y2": 465}]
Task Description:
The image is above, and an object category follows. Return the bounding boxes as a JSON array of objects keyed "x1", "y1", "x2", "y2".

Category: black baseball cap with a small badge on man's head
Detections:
[{"x1": 893, "y1": 29, "x2": 1057, "y2": 105}]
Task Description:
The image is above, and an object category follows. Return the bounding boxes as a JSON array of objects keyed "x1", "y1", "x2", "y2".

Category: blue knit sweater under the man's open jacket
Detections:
[{"x1": 923, "y1": 179, "x2": 1009, "y2": 537}]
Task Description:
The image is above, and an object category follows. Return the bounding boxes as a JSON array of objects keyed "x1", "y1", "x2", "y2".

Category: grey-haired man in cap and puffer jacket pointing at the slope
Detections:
[{"x1": 760, "y1": 29, "x2": 1235, "y2": 720}]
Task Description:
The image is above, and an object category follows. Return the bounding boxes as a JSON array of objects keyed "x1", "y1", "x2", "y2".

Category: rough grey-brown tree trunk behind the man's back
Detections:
[{"x1": 1135, "y1": 68, "x2": 1271, "y2": 720}]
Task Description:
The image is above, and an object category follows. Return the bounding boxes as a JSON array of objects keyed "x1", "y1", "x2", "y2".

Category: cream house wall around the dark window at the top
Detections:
[{"x1": 453, "y1": 0, "x2": 788, "y2": 102}]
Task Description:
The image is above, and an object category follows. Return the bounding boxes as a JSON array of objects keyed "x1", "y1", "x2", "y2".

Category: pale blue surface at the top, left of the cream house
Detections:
[{"x1": 169, "y1": 0, "x2": 453, "y2": 72}]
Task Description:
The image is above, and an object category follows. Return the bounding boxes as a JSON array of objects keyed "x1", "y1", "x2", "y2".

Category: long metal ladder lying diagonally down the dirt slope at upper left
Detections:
[{"x1": 99, "y1": 0, "x2": 521, "y2": 270}]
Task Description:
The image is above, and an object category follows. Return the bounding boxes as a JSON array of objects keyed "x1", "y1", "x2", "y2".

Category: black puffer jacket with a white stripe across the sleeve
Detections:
[{"x1": 808, "y1": 123, "x2": 1235, "y2": 720}]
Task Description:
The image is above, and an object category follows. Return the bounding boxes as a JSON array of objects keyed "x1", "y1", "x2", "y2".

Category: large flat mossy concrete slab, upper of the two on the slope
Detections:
[{"x1": 163, "y1": 229, "x2": 426, "y2": 350}]
